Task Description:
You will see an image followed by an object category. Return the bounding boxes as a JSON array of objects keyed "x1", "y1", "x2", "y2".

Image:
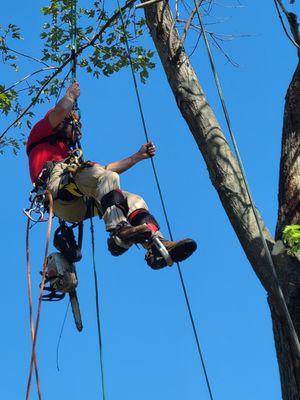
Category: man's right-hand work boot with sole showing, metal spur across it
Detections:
[{"x1": 145, "y1": 239, "x2": 197, "y2": 269}]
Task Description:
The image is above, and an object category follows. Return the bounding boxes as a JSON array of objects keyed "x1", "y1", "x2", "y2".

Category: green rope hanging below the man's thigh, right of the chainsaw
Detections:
[{"x1": 88, "y1": 199, "x2": 106, "y2": 400}]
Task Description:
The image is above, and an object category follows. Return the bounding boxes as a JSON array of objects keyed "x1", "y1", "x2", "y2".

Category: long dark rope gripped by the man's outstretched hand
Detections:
[{"x1": 117, "y1": 0, "x2": 213, "y2": 400}]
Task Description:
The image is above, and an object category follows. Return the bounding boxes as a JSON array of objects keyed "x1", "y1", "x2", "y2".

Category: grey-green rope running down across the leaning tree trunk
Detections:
[{"x1": 194, "y1": 0, "x2": 300, "y2": 359}]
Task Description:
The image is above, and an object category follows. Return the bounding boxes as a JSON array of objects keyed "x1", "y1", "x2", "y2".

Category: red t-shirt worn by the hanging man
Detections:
[{"x1": 26, "y1": 115, "x2": 69, "y2": 182}]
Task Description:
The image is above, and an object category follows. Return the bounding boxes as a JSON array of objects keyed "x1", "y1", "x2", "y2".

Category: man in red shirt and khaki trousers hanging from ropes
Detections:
[{"x1": 26, "y1": 82, "x2": 197, "y2": 269}]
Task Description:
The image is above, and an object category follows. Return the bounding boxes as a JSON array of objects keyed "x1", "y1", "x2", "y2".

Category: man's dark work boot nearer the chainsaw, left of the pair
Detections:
[{"x1": 107, "y1": 224, "x2": 152, "y2": 256}]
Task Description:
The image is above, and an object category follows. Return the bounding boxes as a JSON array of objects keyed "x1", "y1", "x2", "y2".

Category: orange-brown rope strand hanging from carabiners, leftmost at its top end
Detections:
[{"x1": 26, "y1": 218, "x2": 42, "y2": 400}]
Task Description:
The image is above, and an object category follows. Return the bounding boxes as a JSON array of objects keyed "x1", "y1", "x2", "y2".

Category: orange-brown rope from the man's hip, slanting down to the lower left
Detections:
[{"x1": 26, "y1": 190, "x2": 53, "y2": 400}]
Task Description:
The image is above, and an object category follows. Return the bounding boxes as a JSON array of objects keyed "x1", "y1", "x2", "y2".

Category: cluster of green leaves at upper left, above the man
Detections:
[{"x1": 0, "y1": 0, "x2": 155, "y2": 151}]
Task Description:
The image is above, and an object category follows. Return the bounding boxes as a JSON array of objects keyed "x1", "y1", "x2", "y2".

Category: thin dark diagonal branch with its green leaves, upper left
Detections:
[{"x1": 0, "y1": 0, "x2": 154, "y2": 152}]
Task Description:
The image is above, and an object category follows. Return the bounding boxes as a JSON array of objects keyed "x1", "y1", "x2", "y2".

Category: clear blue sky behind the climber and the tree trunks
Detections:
[{"x1": 0, "y1": 0, "x2": 299, "y2": 400}]
